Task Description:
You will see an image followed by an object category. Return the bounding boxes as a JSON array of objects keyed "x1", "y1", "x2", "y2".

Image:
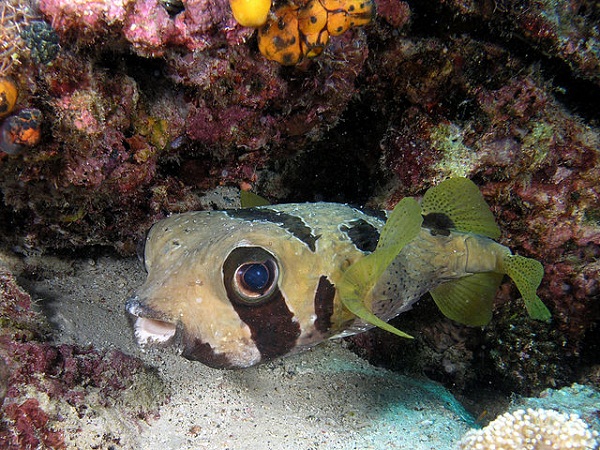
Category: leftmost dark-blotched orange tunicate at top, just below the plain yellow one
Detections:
[{"x1": 258, "y1": 5, "x2": 303, "y2": 66}]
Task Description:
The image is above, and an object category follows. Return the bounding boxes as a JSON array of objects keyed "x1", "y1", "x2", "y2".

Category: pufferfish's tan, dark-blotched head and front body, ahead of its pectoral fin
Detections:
[{"x1": 127, "y1": 203, "x2": 385, "y2": 368}]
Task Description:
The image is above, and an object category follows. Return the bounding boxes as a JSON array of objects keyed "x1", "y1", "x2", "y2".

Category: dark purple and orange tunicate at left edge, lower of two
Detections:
[{"x1": 0, "y1": 109, "x2": 42, "y2": 155}]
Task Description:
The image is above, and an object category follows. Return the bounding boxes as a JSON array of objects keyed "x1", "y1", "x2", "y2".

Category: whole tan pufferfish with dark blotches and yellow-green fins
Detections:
[{"x1": 126, "y1": 178, "x2": 550, "y2": 368}]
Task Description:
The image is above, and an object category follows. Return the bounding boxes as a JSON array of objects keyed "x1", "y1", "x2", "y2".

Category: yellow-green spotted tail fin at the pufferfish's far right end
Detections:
[{"x1": 503, "y1": 255, "x2": 552, "y2": 321}]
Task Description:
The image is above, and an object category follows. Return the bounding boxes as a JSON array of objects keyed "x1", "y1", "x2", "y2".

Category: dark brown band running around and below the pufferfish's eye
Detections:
[{"x1": 223, "y1": 247, "x2": 300, "y2": 361}]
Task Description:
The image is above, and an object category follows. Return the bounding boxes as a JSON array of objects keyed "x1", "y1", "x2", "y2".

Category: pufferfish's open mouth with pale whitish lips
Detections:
[{"x1": 125, "y1": 296, "x2": 179, "y2": 346}]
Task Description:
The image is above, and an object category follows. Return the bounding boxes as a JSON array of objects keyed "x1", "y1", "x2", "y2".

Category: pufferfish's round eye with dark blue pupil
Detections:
[{"x1": 234, "y1": 260, "x2": 278, "y2": 301}]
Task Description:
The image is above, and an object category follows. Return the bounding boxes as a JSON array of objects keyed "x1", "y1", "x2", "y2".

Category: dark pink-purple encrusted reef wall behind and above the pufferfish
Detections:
[{"x1": 0, "y1": 0, "x2": 600, "y2": 402}]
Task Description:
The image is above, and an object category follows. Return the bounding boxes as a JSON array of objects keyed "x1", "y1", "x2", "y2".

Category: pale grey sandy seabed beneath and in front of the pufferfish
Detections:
[{"x1": 7, "y1": 256, "x2": 472, "y2": 450}]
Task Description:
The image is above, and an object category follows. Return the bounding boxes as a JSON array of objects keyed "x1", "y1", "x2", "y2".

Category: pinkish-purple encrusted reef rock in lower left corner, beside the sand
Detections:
[{"x1": 0, "y1": 266, "x2": 166, "y2": 449}]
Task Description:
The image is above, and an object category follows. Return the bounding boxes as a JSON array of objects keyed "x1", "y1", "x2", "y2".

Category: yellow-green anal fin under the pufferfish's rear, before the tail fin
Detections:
[{"x1": 430, "y1": 272, "x2": 503, "y2": 326}]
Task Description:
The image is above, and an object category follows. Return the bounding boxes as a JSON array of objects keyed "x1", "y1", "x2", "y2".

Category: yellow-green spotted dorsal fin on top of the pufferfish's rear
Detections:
[{"x1": 421, "y1": 178, "x2": 500, "y2": 239}]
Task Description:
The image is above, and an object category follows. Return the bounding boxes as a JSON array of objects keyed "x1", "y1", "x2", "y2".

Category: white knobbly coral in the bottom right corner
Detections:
[{"x1": 459, "y1": 409, "x2": 598, "y2": 450}]
